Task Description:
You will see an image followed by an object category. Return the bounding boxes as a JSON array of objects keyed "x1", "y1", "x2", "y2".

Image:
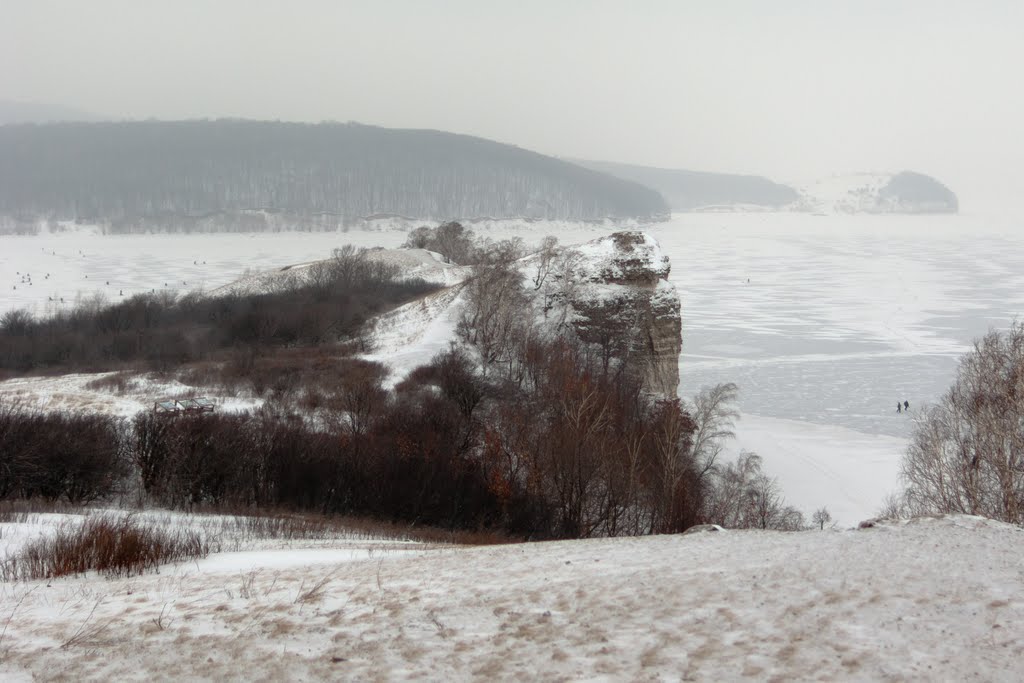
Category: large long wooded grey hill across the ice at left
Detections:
[{"x1": 0, "y1": 120, "x2": 669, "y2": 231}]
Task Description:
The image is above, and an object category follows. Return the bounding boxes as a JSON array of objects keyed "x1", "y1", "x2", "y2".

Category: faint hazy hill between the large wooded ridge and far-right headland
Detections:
[{"x1": 575, "y1": 161, "x2": 800, "y2": 211}]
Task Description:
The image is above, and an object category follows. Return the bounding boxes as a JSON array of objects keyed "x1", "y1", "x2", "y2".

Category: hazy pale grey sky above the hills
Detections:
[{"x1": 0, "y1": 0, "x2": 1024, "y2": 208}]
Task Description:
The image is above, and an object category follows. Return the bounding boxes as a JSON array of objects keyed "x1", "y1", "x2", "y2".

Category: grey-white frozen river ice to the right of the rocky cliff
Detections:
[{"x1": 653, "y1": 214, "x2": 1024, "y2": 436}]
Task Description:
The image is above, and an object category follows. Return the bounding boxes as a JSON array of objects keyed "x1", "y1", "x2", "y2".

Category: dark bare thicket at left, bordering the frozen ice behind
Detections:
[{"x1": 0, "y1": 248, "x2": 437, "y2": 372}]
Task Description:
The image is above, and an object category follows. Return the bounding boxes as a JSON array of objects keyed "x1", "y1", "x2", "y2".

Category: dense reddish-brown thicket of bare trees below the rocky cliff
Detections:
[{"x1": 0, "y1": 341, "x2": 702, "y2": 538}]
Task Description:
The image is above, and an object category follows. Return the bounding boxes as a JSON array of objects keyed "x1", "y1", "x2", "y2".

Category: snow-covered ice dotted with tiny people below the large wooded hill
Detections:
[{"x1": 0, "y1": 220, "x2": 611, "y2": 314}]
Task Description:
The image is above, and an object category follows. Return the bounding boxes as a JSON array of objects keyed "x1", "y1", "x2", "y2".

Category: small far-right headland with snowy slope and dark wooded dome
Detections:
[{"x1": 790, "y1": 171, "x2": 959, "y2": 214}]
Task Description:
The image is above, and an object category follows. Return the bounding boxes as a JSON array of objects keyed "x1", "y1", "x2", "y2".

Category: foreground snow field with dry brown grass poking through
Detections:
[{"x1": 0, "y1": 517, "x2": 1024, "y2": 681}]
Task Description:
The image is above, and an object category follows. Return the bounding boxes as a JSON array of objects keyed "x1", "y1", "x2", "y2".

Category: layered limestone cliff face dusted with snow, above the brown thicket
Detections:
[{"x1": 566, "y1": 230, "x2": 682, "y2": 398}]
